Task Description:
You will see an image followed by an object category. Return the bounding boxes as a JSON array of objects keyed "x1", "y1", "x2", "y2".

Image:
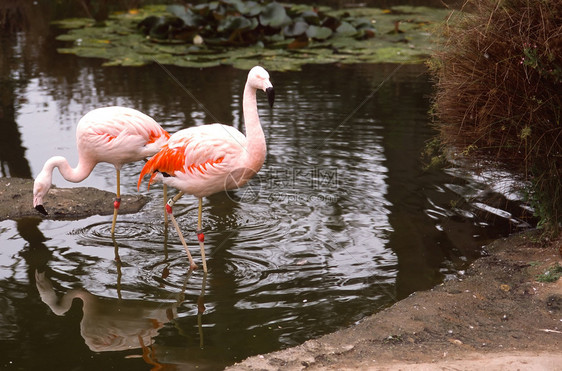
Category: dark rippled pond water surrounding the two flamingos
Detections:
[{"x1": 0, "y1": 1, "x2": 527, "y2": 369}]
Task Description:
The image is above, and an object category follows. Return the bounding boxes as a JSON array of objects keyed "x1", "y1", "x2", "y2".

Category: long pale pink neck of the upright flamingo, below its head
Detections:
[{"x1": 242, "y1": 83, "x2": 266, "y2": 171}]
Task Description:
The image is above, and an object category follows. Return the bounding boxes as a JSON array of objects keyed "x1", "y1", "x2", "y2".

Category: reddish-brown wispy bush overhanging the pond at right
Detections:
[{"x1": 431, "y1": 0, "x2": 562, "y2": 234}]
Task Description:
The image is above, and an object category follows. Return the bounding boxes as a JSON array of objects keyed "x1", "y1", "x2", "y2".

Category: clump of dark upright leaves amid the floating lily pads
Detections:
[{"x1": 134, "y1": 0, "x2": 376, "y2": 48}]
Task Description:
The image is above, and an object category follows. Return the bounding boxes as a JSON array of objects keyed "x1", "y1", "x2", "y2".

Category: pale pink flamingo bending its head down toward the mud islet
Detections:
[{"x1": 33, "y1": 106, "x2": 170, "y2": 236}]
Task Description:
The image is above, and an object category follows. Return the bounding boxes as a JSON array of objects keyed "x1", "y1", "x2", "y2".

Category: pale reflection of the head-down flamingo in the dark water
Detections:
[{"x1": 35, "y1": 270, "x2": 207, "y2": 366}]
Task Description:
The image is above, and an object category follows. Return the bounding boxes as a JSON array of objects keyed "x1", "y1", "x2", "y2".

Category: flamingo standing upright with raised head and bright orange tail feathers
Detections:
[{"x1": 137, "y1": 66, "x2": 275, "y2": 273}]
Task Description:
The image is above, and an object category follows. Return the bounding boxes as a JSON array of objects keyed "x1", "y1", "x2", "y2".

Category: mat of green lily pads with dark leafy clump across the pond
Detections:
[{"x1": 53, "y1": 0, "x2": 447, "y2": 70}]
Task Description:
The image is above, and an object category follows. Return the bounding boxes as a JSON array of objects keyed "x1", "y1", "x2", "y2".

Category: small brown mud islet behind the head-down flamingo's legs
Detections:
[{"x1": 0, "y1": 178, "x2": 148, "y2": 220}]
